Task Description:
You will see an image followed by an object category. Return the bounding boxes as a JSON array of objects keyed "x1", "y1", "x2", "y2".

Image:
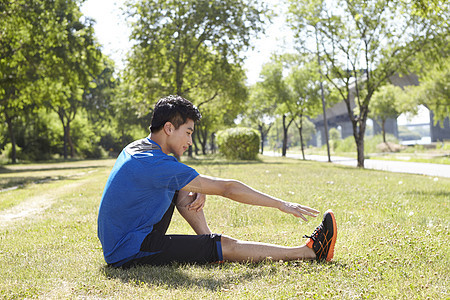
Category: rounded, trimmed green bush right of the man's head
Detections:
[{"x1": 216, "y1": 127, "x2": 260, "y2": 160}]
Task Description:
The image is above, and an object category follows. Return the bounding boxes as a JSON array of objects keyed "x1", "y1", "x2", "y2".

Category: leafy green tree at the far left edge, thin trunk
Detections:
[{"x1": 0, "y1": 0, "x2": 50, "y2": 163}]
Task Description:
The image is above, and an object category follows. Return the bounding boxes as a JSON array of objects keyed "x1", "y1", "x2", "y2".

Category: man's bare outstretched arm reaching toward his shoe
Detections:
[{"x1": 182, "y1": 175, "x2": 319, "y2": 221}]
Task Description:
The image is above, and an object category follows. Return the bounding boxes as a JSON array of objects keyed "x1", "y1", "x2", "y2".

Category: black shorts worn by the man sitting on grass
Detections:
[{"x1": 116, "y1": 193, "x2": 223, "y2": 268}]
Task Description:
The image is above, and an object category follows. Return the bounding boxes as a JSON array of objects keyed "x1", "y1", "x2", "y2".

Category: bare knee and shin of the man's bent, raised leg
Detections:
[{"x1": 176, "y1": 191, "x2": 212, "y2": 234}]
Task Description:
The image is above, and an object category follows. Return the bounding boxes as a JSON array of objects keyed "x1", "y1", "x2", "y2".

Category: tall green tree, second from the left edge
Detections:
[{"x1": 43, "y1": 0, "x2": 102, "y2": 159}]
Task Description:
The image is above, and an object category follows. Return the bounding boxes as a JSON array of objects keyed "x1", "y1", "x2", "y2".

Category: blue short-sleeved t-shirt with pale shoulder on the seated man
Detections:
[{"x1": 97, "y1": 138, "x2": 198, "y2": 264}]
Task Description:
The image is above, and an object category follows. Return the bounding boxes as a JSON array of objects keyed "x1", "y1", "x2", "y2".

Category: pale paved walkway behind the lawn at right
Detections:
[{"x1": 264, "y1": 151, "x2": 450, "y2": 178}]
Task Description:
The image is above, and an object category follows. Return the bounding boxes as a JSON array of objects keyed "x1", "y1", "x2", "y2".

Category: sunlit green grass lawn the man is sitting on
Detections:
[{"x1": 0, "y1": 157, "x2": 450, "y2": 299}]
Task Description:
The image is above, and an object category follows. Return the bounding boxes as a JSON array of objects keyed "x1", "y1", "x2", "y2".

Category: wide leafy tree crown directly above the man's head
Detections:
[{"x1": 127, "y1": 0, "x2": 267, "y2": 101}]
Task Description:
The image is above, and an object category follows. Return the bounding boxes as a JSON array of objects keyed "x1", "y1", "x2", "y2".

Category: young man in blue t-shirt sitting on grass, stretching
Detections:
[{"x1": 98, "y1": 96, "x2": 337, "y2": 267}]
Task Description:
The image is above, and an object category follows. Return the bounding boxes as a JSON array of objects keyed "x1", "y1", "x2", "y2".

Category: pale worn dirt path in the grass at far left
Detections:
[{"x1": 0, "y1": 180, "x2": 85, "y2": 228}]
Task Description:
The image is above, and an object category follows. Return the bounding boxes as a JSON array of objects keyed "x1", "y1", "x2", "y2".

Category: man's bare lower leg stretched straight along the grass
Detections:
[{"x1": 222, "y1": 235, "x2": 316, "y2": 262}]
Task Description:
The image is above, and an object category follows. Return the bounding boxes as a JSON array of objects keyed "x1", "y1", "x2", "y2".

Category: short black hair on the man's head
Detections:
[{"x1": 150, "y1": 95, "x2": 202, "y2": 132}]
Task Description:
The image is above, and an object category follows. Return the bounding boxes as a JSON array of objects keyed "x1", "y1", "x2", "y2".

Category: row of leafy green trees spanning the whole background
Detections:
[{"x1": 0, "y1": 0, "x2": 450, "y2": 167}]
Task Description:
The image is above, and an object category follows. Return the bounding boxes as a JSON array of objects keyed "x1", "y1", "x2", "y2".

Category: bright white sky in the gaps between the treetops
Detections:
[{"x1": 81, "y1": 0, "x2": 293, "y2": 84}]
